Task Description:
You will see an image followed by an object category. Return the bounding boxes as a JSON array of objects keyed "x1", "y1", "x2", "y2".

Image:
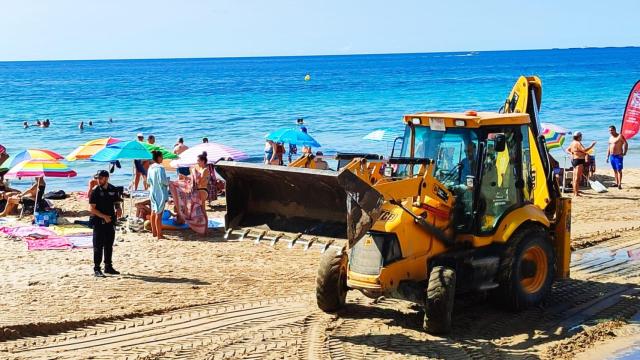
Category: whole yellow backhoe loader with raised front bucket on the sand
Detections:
[{"x1": 217, "y1": 77, "x2": 571, "y2": 333}]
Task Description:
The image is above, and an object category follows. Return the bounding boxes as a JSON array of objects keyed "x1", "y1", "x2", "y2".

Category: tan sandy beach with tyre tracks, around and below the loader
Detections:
[{"x1": 0, "y1": 169, "x2": 640, "y2": 358}]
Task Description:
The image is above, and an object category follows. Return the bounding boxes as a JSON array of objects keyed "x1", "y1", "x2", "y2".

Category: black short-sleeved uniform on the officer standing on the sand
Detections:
[{"x1": 89, "y1": 184, "x2": 122, "y2": 270}]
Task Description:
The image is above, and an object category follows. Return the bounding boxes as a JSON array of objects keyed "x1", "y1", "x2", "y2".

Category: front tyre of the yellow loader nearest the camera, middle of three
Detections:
[{"x1": 423, "y1": 266, "x2": 456, "y2": 334}]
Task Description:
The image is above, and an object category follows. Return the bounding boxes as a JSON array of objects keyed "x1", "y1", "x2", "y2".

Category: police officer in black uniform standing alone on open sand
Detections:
[{"x1": 89, "y1": 170, "x2": 122, "y2": 277}]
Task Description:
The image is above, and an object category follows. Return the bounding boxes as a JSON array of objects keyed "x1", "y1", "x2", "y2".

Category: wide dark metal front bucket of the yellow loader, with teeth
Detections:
[{"x1": 216, "y1": 161, "x2": 383, "y2": 243}]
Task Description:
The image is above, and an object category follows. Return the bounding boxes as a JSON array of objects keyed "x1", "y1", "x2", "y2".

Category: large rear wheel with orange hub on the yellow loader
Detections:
[{"x1": 496, "y1": 227, "x2": 555, "y2": 311}]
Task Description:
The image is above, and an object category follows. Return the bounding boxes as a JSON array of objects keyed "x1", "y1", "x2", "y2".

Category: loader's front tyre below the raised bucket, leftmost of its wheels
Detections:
[{"x1": 316, "y1": 251, "x2": 348, "y2": 312}]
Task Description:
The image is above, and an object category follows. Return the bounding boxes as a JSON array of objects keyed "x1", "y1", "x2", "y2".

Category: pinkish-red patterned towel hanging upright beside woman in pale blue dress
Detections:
[{"x1": 169, "y1": 179, "x2": 207, "y2": 234}]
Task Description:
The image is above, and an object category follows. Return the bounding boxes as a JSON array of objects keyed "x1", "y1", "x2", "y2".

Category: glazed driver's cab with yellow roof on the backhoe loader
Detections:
[{"x1": 392, "y1": 112, "x2": 534, "y2": 235}]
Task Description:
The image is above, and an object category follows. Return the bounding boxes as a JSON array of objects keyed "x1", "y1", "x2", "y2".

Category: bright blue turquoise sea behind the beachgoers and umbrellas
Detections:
[{"x1": 0, "y1": 48, "x2": 640, "y2": 190}]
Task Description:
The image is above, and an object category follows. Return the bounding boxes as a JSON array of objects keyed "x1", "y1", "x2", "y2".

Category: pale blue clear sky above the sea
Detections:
[{"x1": 0, "y1": 0, "x2": 640, "y2": 61}]
